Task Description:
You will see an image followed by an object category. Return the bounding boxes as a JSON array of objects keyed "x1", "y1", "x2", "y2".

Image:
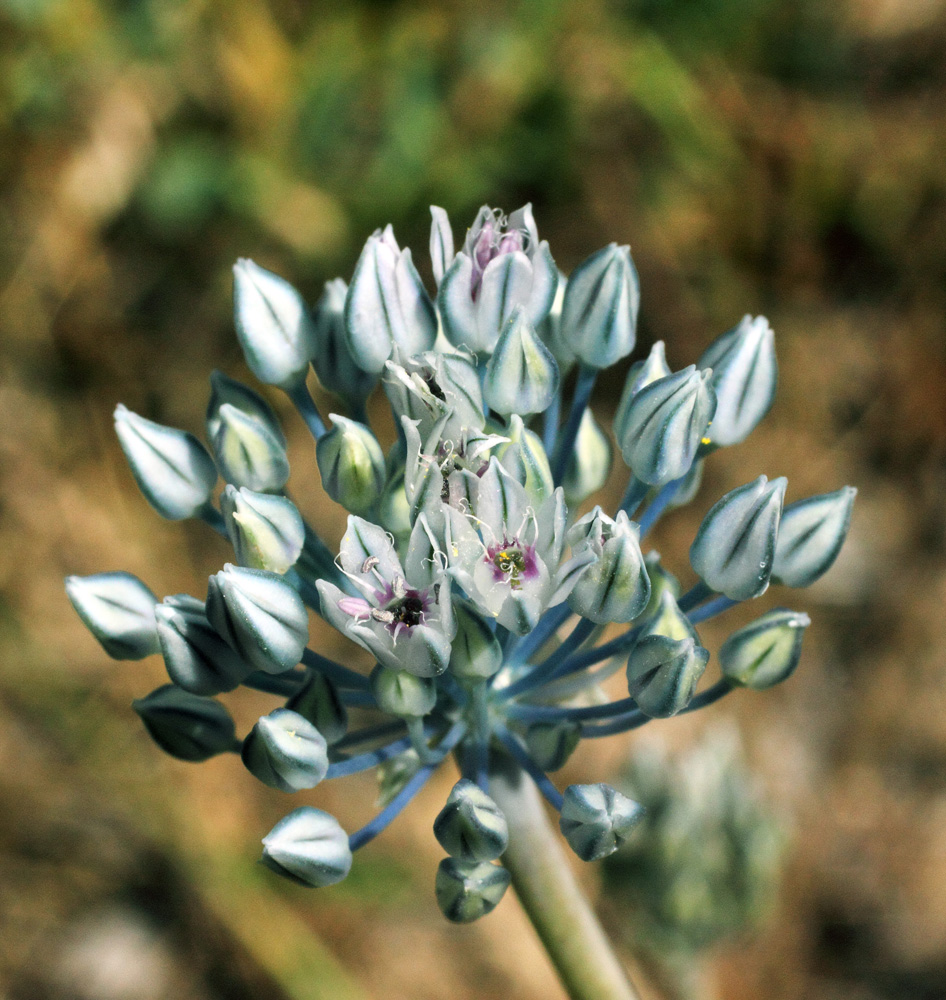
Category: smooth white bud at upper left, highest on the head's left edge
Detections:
[{"x1": 233, "y1": 259, "x2": 316, "y2": 389}]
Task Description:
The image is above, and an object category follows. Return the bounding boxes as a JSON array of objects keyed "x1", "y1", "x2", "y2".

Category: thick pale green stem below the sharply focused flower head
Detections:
[{"x1": 490, "y1": 765, "x2": 640, "y2": 1000}]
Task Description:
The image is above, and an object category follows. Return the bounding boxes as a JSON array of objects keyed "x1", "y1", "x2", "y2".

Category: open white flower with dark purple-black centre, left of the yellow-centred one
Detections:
[{"x1": 317, "y1": 515, "x2": 456, "y2": 677}]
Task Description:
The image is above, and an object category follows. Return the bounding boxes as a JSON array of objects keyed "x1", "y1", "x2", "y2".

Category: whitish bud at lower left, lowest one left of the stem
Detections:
[{"x1": 260, "y1": 806, "x2": 351, "y2": 888}]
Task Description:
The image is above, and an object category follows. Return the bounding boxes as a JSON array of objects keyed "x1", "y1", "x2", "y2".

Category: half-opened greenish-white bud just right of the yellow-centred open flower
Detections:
[{"x1": 568, "y1": 507, "x2": 650, "y2": 625}]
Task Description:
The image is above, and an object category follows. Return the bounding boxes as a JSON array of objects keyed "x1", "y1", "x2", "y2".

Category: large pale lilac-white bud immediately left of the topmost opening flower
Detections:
[{"x1": 345, "y1": 226, "x2": 437, "y2": 375}]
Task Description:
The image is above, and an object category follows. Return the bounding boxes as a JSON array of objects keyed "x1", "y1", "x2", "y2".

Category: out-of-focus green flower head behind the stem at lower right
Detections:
[{"x1": 604, "y1": 726, "x2": 785, "y2": 952}]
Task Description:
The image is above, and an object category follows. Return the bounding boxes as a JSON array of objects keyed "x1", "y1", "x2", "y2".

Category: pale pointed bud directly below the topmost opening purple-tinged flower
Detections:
[{"x1": 483, "y1": 306, "x2": 559, "y2": 416}]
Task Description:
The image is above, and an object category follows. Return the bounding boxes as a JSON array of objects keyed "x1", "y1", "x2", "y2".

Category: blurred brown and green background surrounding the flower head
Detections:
[{"x1": 0, "y1": 0, "x2": 946, "y2": 1000}]
